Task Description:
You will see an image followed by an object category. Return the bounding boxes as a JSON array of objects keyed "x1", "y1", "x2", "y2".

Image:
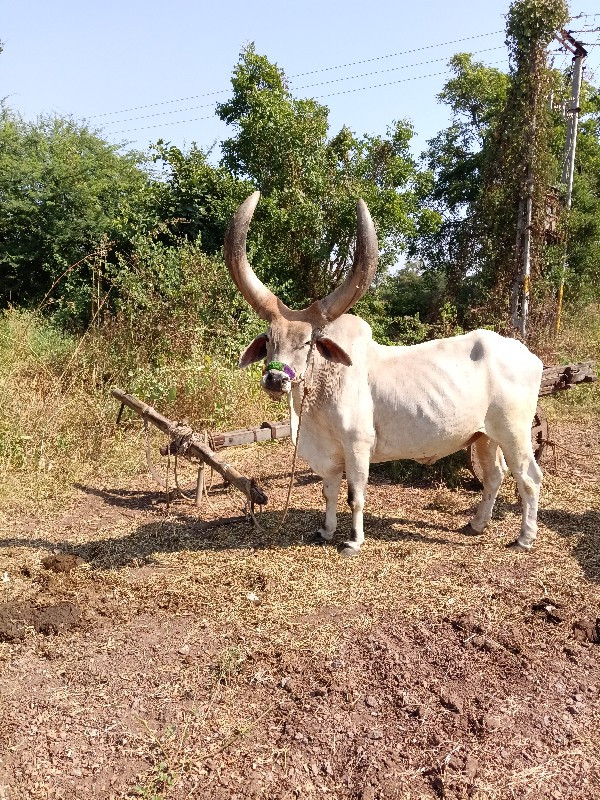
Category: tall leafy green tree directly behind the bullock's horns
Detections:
[{"x1": 217, "y1": 45, "x2": 437, "y2": 304}]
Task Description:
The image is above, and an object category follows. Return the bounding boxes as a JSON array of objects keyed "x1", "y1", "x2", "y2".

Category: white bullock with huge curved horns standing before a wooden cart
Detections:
[{"x1": 225, "y1": 192, "x2": 542, "y2": 556}]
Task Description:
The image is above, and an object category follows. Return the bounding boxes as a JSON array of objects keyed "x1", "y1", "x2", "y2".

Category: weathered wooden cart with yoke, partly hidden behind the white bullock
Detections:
[{"x1": 112, "y1": 361, "x2": 596, "y2": 511}]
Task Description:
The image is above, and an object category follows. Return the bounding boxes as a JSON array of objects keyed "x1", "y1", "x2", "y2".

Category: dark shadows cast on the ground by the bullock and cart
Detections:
[{"x1": 0, "y1": 472, "x2": 600, "y2": 582}]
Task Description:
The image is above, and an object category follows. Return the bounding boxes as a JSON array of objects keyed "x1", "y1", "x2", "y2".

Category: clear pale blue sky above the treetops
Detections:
[{"x1": 0, "y1": 0, "x2": 600, "y2": 161}]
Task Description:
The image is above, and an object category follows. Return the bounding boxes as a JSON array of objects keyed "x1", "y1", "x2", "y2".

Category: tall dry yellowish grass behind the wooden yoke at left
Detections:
[{"x1": 0, "y1": 311, "x2": 273, "y2": 515}]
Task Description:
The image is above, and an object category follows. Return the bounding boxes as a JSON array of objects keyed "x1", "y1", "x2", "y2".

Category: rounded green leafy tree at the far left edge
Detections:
[{"x1": 0, "y1": 110, "x2": 148, "y2": 313}]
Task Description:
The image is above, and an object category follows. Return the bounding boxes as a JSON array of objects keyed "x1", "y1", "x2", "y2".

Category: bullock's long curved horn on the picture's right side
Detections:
[{"x1": 316, "y1": 200, "x2": 379, "y2": 322}]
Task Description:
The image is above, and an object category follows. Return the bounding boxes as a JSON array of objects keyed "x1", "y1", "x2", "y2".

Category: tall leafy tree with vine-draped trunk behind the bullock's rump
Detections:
[{"x1": 415, "y1": 0, "x2": 567, "y2": 334}]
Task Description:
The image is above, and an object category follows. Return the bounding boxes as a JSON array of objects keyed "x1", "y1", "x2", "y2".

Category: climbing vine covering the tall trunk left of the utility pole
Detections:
[{"x1": 473, "y1": 0, "x2": 568, "y2": 335}]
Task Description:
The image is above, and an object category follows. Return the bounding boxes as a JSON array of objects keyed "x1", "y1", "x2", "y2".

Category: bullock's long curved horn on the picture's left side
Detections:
[{"x1": 225, "y1": 192, "x2": 287, "y2": 322}]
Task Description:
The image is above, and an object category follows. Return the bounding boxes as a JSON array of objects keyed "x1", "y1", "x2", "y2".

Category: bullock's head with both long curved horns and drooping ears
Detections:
[{"x1": 225, "y1": 192, "x2": 378, "y2": 398}]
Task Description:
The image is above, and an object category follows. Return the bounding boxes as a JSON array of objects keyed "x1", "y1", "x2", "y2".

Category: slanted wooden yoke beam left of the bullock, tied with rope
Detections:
[{"x1": 112, "y1": 387, "x2": 268, "y2": 506}]
